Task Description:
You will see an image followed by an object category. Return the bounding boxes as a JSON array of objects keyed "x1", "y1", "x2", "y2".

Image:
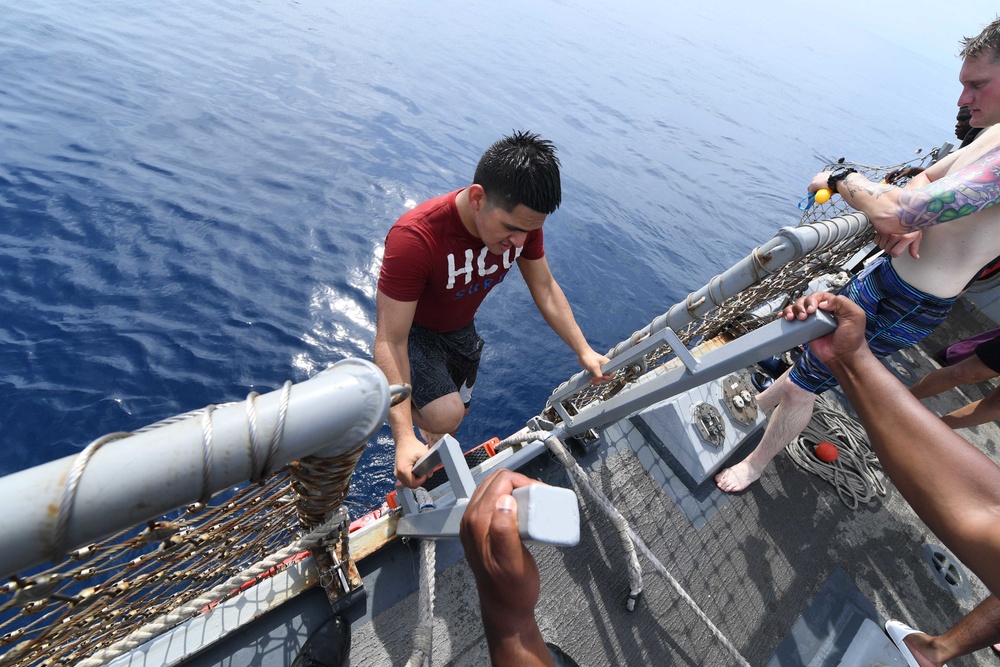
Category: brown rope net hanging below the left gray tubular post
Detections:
[{"x1": 0, "y1": 418, "x2": 363, "y2": 667}]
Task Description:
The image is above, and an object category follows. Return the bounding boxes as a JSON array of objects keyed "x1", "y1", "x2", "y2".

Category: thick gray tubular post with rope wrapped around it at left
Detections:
[{"x1": 0, "y1": 359, "x2": 391, "y2": 578}]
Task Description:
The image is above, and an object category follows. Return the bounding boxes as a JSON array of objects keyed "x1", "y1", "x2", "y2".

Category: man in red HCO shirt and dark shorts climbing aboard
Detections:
[{"x1": 374, "y1": 132, "x2": 610, "y2": 488}]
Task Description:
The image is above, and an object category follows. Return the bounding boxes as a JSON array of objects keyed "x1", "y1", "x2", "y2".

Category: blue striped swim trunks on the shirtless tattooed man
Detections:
[{"x1": 788, "y1": 257, "x2": 957, "y2": 394}]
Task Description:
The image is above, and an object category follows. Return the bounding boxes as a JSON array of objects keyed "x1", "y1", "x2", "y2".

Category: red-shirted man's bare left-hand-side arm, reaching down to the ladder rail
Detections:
[{"x1": 372, "y1": 290, "x2": 427, "y2": 489}]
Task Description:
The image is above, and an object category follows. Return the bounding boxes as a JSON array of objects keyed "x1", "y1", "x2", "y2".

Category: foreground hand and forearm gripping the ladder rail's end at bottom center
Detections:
[{"x1": 460, "y1": 470, "x2": 552, "y2": 667}]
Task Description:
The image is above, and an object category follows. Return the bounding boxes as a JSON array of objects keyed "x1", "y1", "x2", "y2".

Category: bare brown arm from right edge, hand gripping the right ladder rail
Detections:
[{"x1": 785, "y1": 293, "x2": 1000, "y2": 595}]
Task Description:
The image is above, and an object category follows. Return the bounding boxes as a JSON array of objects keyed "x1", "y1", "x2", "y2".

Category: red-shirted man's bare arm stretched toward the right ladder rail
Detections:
[{"x1": 517, "y1": 257, "x2": 612, "y2": 384}]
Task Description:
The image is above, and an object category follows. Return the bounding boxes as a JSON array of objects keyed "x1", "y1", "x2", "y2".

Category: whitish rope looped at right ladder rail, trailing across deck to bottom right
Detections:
[{"x1": 496, "y1": 431, "x2": 750, "y2": 667}]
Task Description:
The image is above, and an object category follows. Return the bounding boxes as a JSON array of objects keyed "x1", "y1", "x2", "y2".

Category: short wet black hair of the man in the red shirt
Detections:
[{"x1": 473, "y1": 131, "x2": 562, "y2": 215}]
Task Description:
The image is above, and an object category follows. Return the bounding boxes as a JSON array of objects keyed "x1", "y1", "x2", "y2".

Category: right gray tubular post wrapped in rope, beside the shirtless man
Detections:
[{"x1": 548, "y1": 213, "x2": 870, "y2": 405}]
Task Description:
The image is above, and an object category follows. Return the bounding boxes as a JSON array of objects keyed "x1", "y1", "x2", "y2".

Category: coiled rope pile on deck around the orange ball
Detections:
[{"x1": 788, "y1": 395, "x2": 886, "y2": 510}]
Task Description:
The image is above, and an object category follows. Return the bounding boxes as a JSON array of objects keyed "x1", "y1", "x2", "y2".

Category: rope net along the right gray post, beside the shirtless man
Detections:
[{"x1": 544, "y1": 155, "x2": 937, "y2": 423}]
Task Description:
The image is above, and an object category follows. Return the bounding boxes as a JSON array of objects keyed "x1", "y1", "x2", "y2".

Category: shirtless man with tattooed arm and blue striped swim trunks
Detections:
[{"x1": 715, "y1": 19, "x2": 1000, "y2": 492}]
